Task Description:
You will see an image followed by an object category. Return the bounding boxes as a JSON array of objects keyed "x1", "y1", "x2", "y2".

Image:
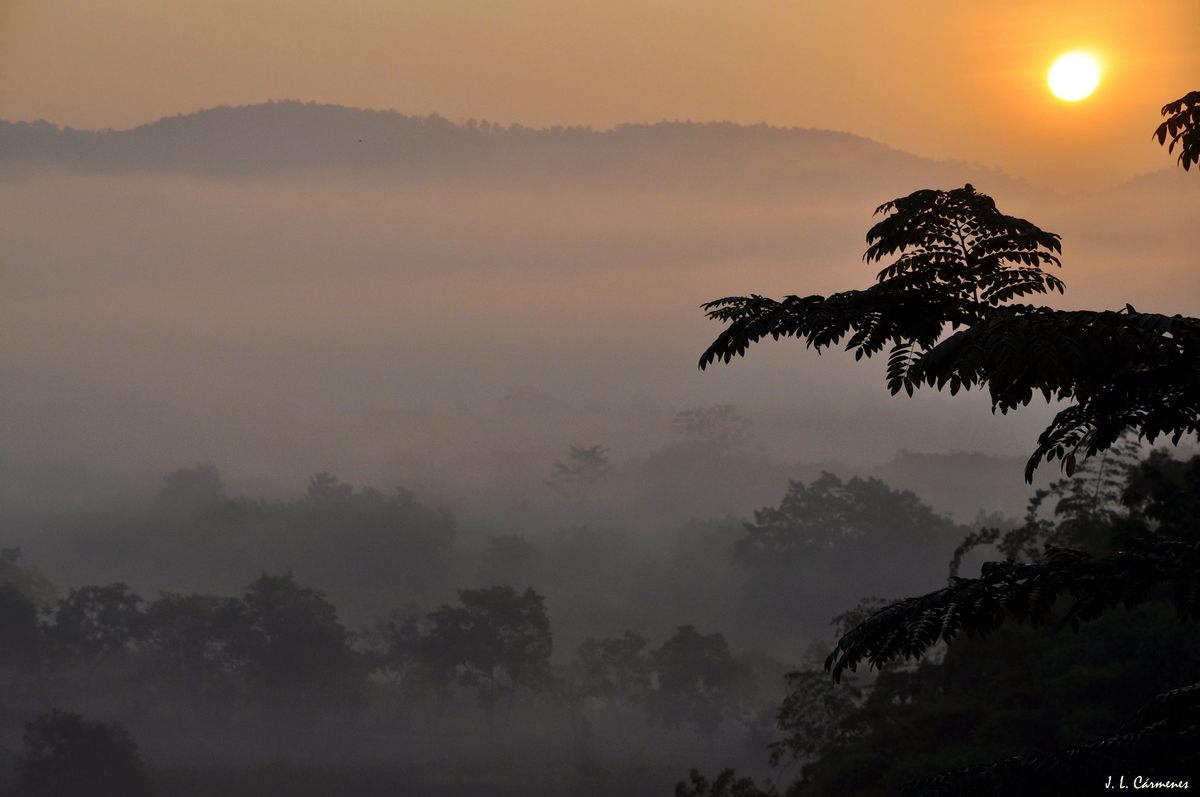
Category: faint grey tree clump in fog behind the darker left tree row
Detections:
[{"x1": 141, "y1": 466, "x2": 455, "y2": 609}]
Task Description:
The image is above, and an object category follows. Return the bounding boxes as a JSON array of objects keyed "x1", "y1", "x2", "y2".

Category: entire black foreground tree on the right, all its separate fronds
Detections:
[{"x1": 691, "y1": 92, "x2": 1200, "y2": 796}]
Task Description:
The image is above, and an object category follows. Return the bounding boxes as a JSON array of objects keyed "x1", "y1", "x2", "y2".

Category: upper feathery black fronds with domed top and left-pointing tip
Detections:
[{"x1": 700, "y1": 184, "x2": 1062, "y2": 369}]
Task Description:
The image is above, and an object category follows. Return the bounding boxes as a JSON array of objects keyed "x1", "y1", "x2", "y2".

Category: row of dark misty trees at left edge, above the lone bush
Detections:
[{"x1": 28, "y1": 571, "x2": 367, "y2": 707}]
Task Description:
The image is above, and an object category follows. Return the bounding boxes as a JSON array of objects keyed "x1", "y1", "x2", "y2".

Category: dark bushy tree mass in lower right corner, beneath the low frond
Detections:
[{"x1": 790, "y1": 600, "x2": 1200, "y2": 797}]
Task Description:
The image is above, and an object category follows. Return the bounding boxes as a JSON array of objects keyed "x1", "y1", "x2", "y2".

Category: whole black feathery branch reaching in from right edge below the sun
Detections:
[{"x1": 700, "y1": 184, "x2": 1200, "y2": 480}]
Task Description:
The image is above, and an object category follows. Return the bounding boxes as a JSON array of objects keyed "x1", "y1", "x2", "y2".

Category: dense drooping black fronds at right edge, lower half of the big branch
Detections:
[{"x1": 912, "y1": 305, "x2": 1200, "y2": 481}]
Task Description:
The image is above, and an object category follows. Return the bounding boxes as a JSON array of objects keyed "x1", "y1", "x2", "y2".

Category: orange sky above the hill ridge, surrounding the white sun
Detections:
[{"x1": 0, "y1": 0, "x2": 1200, "y2": 190}]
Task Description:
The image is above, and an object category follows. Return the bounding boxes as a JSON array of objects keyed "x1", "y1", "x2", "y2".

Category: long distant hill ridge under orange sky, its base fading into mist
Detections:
[{"x1": 0, "y1": 101, "x2": 1028, "y2": 196}]
